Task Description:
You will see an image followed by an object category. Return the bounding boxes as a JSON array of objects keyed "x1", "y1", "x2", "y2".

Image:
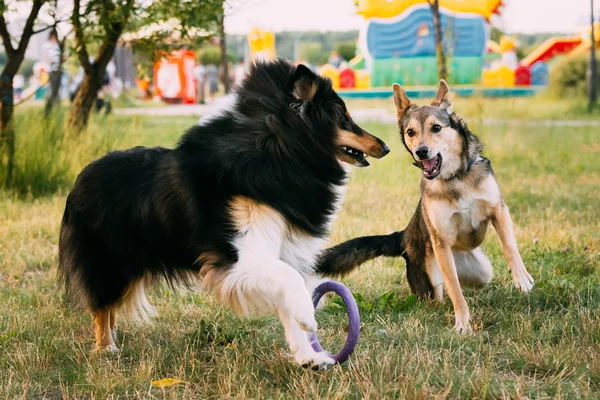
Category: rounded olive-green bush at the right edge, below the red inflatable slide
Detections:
[{"x1": 549, "y1": 54, "x2": 600, "y2": 98}]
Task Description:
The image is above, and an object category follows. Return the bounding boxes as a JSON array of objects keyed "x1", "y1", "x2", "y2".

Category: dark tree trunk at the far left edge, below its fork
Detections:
[{"x1": 0, "y1": 73, "x2": 15, "y2": 186}]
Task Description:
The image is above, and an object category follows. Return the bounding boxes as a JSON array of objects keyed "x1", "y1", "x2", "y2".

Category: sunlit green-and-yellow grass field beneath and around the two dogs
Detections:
[{"x1": 0, "y1": 99, "x2": 600, "y2": 399}]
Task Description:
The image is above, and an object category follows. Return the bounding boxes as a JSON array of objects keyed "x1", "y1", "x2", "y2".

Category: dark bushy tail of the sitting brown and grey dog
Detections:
[{"x1": 316, "y1": 231, "x2": 404, "y2": 276}]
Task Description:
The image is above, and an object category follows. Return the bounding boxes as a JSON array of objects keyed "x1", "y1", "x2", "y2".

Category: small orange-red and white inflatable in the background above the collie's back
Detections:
[{"x1": 154, "y1": 50, "x2": 196, "y2": 104}]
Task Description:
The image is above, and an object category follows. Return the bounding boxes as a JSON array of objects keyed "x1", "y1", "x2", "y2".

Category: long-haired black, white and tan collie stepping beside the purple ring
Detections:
[{"x1": 59, "y1": 60, "x2": 389, "y2": 370}]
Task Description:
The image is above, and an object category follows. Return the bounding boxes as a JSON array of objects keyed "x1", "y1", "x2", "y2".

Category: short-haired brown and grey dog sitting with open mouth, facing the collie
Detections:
[{"x1": 319, "y1": 80, "x2": 533, "y2": 333}]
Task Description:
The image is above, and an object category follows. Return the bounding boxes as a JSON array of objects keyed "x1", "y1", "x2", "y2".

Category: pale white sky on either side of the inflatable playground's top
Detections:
[{"x1": 225, "y1": 0, "x2": 600, "y2": 34}]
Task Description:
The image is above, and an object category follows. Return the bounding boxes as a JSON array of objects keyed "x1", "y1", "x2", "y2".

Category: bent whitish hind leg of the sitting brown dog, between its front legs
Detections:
[{"x1": 452, "y1": 247, "x2": 494, "y2": 287}]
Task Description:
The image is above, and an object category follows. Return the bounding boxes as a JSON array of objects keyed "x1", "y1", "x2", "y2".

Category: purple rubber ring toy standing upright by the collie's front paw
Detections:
[{"x1": 310, "y1": 281, "x2": 360, "y2": 364}]
